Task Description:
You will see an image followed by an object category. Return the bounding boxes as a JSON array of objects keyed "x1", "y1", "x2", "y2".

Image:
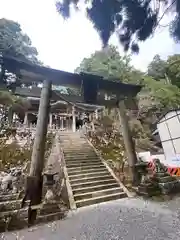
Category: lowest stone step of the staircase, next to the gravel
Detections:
[{"x1": 76, "y1": 192, "x2": 127, "y2": 207}]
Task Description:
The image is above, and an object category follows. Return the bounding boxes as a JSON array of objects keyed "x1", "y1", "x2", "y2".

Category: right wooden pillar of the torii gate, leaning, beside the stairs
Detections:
[{"x1": 118, "y1": 100, "x2": 138, "y2": 185}]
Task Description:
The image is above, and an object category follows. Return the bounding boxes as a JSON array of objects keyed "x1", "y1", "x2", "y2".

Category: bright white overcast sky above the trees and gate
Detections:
[{"x1": 0, "y1": 0, "x2": 180, "y2": 72}]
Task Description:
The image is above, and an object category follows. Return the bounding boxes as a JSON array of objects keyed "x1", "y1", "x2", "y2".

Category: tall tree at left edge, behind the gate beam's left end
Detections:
[{"x1": 0, "y1": 18, "x2": 41, "y2": 91}]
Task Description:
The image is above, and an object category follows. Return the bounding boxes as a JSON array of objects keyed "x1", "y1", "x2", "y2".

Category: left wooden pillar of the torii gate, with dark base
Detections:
[{"x1": 22, "y1": 80, "x2": 51, "y2": 224}]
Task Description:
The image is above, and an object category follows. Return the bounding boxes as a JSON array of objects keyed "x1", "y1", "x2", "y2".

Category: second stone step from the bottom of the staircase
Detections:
[{"x1": 74, "y1": 187, "x2": 123, "y2": 201}]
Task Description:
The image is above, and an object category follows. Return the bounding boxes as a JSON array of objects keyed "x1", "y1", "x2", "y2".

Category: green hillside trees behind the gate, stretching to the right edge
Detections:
[{"x1": 76, "y1": 45, "x2": 180, "y2": 123}]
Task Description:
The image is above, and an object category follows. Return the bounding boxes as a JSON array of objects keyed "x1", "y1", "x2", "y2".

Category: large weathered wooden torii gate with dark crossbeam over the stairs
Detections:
[{"x1": 1, "y1": 56, "x2": 141, "y2": 219}]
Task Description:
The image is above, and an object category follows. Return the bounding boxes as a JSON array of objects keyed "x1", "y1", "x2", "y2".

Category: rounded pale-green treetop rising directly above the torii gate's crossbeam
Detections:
[{"x1": 75, "y1": 45, "x2": 142, "y2": 83}]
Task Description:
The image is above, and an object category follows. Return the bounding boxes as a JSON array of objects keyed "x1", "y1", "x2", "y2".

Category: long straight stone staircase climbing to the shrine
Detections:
[{"x1": 60, "y1": 132, "x2": 129, "y2": 208}]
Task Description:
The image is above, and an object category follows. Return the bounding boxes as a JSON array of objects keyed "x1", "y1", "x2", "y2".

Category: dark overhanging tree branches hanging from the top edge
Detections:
[{"x1": 56, "y1": 0, "x2": 180, "y2": 52}]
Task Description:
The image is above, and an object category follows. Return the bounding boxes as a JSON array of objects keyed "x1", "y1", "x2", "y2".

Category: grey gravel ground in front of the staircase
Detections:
[{"x1": 1, "y1": 198, "x2": 180, "y2": 240}]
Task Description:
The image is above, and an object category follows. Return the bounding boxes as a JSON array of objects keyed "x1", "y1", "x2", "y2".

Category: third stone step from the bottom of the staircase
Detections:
[{"x1": 73, "y1": 182, "x2": 119, "y2": 195}]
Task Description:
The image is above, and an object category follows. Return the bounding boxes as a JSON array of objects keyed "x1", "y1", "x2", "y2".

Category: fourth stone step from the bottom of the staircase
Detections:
[{"x1": 71, "y1": 179, "x2": 116, "y2": 191}]
